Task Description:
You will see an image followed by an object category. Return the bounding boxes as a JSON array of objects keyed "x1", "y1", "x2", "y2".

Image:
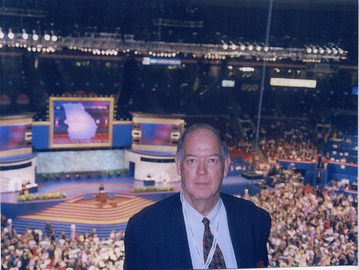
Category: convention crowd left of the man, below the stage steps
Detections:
[{"x1": 1, "y1": 226, "x2": 124, "y2": 270}]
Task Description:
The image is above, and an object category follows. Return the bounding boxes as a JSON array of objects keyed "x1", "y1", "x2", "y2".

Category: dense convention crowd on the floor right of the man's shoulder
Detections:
[{"x1": 248, "y1": 172, "x2": 358, "y2": 267}]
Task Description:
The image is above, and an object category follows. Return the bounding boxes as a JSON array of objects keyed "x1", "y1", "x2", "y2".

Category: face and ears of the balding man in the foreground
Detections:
[{"x1": 176, "y1": 129, "x2": 230, "y2": 210}]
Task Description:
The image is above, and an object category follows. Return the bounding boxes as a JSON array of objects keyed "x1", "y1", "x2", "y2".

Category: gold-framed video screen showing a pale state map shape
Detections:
[{"x1": 49, "y1": 97, "x2": 114, "y2": 148}]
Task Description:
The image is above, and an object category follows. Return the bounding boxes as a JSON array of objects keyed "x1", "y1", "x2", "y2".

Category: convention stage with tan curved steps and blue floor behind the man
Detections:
[{"x1": 1, "y1": 175, "x2": 260, "y2": 237}]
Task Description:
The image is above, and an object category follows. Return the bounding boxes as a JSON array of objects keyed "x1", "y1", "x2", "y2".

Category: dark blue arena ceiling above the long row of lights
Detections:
[{"x1": 0, "y1": 0, "x2": 358, "y2": 63}]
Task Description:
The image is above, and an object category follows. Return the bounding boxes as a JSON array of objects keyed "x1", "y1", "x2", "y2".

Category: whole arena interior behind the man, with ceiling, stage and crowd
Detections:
[{"x1": 0, "y1": 0, "x2": 359, "y2": 269}]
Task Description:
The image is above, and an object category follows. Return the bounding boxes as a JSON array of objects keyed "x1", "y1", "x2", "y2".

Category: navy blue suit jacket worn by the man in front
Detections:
[{"x1": 124, "y1": 193, "x2": 271, "y2": 270}]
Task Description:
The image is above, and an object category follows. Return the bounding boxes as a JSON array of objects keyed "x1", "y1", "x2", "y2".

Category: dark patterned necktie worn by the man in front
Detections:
[{"x1": 202, "y1": 218, "x2": 226, "y2": 269}]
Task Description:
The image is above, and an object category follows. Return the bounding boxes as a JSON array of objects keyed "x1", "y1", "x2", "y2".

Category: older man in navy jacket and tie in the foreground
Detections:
[{"x1": 124, "y1": 124, "x2": 271, "y2": 270}]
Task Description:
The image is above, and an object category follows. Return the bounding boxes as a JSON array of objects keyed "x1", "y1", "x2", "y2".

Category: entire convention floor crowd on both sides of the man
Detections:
[{"x1": 1, "y1": 174, "x2": 358, "y2": 270}]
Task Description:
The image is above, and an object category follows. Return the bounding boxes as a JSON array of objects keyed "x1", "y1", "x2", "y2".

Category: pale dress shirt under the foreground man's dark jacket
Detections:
[{"x1": 180, "y1": 192, "x2": 237, "y2": 269}]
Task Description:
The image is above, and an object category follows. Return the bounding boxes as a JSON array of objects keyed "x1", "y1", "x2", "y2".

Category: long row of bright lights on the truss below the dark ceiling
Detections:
[{"x1": 0, "y1": 28, "x2": 348, "y2": 63}]
